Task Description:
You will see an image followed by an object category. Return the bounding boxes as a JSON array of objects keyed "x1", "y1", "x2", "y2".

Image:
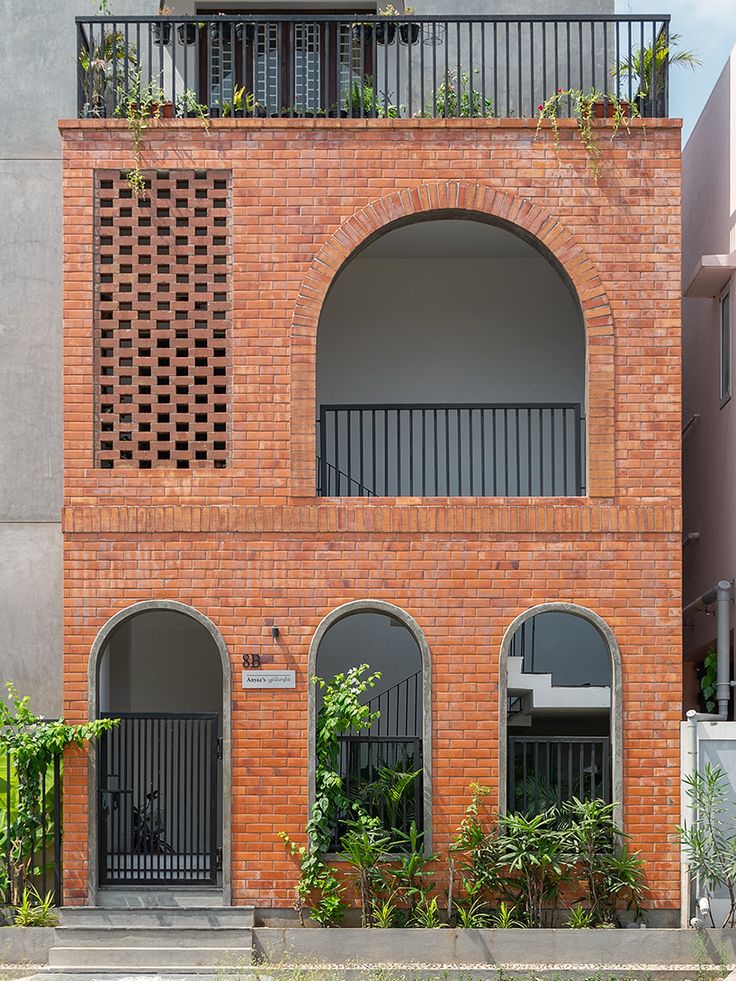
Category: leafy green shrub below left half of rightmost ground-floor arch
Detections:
[{"x1": 499, "y1": 807, "x2": 568, "y2": 927}]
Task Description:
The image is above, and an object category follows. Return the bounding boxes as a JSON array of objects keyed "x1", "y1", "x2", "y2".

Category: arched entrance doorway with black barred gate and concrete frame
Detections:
[{"x1": 89, "y1": 601, "x2": 230, "y2": 895}]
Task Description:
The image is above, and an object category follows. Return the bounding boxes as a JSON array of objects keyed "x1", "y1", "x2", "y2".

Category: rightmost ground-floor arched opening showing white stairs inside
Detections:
[{"x1": 499, "y1": 603, "x2": 623, "y2": 819}]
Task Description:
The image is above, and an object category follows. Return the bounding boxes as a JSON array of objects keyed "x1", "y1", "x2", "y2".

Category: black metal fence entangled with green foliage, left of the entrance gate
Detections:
[{"x1": 0, "y1": 754, "x2": 63, "y2": 906}]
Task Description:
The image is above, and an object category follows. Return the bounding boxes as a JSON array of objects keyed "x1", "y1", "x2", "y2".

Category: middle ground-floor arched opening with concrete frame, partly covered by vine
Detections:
[{"x1": 308, "y1": 600, "x2": 432, "y2": 848}]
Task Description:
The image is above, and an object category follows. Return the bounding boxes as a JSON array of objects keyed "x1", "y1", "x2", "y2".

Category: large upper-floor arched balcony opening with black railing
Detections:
[{"x1": 316, "y1": 212, "x2": 586, "y2": 497}]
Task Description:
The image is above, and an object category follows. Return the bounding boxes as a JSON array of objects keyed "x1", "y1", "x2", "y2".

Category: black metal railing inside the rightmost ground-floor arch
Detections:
[{"x1": 508, "y1": 736, "x2": 611, "y2": 814}]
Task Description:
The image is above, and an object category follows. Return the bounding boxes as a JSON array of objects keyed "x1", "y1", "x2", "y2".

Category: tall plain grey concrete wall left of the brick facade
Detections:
[{"x1": 0, "y1": 0, "x2": 156, "y2": 716}]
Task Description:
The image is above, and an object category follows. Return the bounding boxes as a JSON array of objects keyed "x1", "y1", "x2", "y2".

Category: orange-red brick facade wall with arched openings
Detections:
[{"x1": 62, "y1": 120, "x2": 681, "y2": 907}]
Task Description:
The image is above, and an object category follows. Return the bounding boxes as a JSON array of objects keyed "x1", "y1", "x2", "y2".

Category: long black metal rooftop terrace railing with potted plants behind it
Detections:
[{"x1": 76, "y1": 13, "x2": 669, "y2": 118}]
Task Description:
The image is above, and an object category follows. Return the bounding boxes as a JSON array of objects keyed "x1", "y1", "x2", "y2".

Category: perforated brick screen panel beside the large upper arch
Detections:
[{"x1": 94, "y1": 170, "x2": 232, "y2": 469}]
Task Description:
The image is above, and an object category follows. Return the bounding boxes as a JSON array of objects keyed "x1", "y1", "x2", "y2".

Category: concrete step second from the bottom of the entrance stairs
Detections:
[{"x1": 54, "y1": 925, "x2": 252, "y2": 950}]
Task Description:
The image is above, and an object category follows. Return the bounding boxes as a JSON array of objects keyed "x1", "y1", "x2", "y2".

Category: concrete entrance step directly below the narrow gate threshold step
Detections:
[{"x1": 59, "y1": 906, "x2": 253, "y2": 930}]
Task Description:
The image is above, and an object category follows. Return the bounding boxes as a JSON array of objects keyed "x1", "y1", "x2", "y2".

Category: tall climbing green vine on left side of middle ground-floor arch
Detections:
[{"x1": 279, "y1": 664, "x2": 381, "y2": 924}]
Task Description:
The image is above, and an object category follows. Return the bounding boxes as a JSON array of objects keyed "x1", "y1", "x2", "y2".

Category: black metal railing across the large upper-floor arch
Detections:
[{"x1": 317, "y1": 403, "x2": 585, "y2": 497}]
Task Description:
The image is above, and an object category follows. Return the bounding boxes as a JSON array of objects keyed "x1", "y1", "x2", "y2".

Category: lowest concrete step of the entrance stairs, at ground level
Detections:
[{"x1": 48, "y1": 945, "x2": 252, "y2": 974}]
